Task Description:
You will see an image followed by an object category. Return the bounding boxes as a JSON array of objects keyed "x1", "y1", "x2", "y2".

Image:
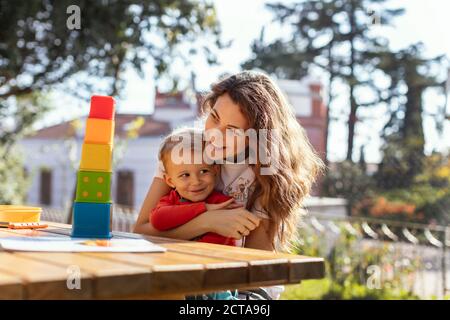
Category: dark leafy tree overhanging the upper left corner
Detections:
[{"x1": 0, "y1": 0, "x2": 222, "y2": 202}]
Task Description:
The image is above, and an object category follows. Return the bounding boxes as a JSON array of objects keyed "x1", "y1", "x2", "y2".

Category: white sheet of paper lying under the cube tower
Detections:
[{"x1": 0, "y1": 237, "x2": 166, "y2": 252}]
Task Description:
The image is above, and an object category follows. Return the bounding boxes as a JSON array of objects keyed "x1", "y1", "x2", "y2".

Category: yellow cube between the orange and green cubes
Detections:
[{"x1": 80, "y1": 143, "x2": 112, "y2": 172}]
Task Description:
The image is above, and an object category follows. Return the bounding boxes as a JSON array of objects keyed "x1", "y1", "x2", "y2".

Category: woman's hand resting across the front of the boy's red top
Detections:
[{"x1": 196, "y1": 208, "x2": 261, "y2": 240}]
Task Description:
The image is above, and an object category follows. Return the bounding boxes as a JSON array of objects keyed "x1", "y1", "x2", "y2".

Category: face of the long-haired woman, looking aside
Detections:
[{"x1": 205, "y1": 93, "x2": 249, "y2": 160}]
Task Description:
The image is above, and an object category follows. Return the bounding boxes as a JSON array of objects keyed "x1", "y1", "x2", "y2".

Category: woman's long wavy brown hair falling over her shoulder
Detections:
[{"x1": 202, "y1": 71, "x2": 323, "y2": 251}]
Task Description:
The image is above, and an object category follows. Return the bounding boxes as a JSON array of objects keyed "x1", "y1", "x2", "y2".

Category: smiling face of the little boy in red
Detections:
[{"x1": 164, "y1": 151, "x2": 218, "y2": 202}]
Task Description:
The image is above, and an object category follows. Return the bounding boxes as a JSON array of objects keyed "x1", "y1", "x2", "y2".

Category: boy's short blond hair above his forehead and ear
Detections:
[{"x1": 158, "y1": 127, "x2": 204, "y2": 171}]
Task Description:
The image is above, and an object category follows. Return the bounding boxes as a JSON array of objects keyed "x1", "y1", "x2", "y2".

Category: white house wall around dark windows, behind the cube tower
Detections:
[{"x1": 21, "y1": 136, "x2": 162, "y2": 209}]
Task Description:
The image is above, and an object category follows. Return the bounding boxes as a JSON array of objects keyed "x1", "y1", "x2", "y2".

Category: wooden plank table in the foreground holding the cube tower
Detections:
[{"x1": 0, "y1": 222, "x2": 324, "y2": 299}]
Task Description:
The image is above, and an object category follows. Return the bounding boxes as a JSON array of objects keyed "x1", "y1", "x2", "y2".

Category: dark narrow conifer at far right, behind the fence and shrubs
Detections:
[{"x1": 377, "y1": 44, "x2": 444, "y2": 188}]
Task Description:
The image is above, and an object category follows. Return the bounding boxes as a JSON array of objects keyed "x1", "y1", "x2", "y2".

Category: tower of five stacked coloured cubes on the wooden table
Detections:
[{"x1": 72, "y1": 96, "x2": 115, "y2": 238}]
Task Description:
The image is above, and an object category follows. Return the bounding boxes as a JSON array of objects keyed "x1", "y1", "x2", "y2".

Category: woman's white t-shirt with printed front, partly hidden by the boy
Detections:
[{"x1": 155, "y1": 161, "x2": 284, "y2": 299}]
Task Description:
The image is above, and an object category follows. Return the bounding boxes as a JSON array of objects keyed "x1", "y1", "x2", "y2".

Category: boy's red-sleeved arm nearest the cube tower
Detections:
[{"x1": 150, "y1": 196, "x2": 206, "y2": 231}]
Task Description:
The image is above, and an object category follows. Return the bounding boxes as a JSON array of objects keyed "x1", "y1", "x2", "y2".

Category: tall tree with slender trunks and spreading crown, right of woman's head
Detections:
[{"x1": 243, "y1": 0, "x2": 403, "y2": 161}]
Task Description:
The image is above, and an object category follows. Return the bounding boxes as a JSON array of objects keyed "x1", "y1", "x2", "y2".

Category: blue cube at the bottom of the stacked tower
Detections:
[{"x1": 72, "y1": 201, "x2": 112, "y2": 239}]
